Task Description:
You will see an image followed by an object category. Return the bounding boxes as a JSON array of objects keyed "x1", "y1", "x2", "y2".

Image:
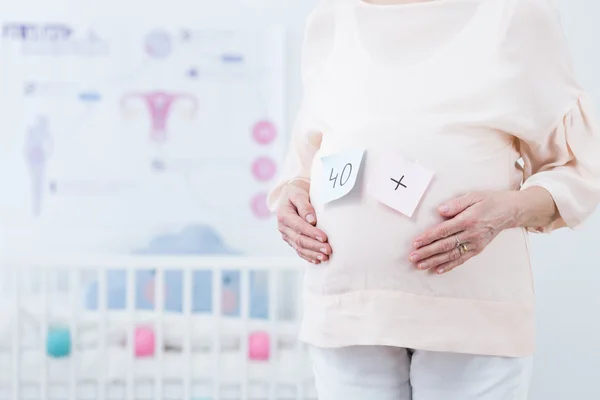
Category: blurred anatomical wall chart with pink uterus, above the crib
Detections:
[{"x1": 0, "y1": 21, "x2": 286, "y2": 254}]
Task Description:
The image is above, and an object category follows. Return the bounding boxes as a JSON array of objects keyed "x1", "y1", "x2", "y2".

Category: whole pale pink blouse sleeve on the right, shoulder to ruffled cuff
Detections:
[{"x1": 513, "y1": 0, "x2": 600, "y2": 232}]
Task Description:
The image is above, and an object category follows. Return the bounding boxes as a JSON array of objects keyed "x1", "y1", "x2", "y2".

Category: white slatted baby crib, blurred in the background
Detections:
[{"x1": 0, "y1": 256, "x2": 316, "y2": 400}]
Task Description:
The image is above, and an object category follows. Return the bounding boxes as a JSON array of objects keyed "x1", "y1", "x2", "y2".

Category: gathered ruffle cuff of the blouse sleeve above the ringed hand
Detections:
[{"x1": 519, "y1": 95, "x2": 600, "y2": 232}]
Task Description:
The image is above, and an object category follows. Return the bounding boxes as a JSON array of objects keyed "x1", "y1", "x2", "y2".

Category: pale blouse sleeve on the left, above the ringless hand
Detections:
[{"x1": 267, "y1": 1, "x2": 334, "y2": 212}]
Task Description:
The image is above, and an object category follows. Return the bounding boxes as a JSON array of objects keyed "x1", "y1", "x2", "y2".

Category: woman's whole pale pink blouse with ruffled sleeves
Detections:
[{"x1": 269, "y1": 0, "x2": 600, "y2": 357}]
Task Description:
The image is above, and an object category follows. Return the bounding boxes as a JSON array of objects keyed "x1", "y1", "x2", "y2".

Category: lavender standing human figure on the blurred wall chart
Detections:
[{"x1": 23, "y1": 116, "x2": 53, "y2": 217}]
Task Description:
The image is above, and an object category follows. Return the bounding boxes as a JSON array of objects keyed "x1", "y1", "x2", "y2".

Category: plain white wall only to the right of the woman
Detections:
[{"x1": 531, "y1": 0, "x2": 600, "y2": 400}]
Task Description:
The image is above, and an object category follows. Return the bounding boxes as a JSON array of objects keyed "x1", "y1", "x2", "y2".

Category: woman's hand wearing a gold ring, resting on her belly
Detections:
[{"x1": 410, "y1": 191, "x2": 519, "y2": 274}]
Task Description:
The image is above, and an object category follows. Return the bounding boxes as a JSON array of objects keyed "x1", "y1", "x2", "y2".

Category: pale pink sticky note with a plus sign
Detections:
[{"x1": 367, "y1": 155, "x2": 433, "y2": 217}]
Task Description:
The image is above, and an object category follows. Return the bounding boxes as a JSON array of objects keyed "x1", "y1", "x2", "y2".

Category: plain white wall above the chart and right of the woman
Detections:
[{"x1": 0, "y1": 0, "x2": 600, "y2": 400}]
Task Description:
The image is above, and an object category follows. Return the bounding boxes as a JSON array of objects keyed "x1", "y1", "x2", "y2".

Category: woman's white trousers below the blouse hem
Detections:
[{"x1": 310, "y1": 346, "x2": 533, "y2": 400}]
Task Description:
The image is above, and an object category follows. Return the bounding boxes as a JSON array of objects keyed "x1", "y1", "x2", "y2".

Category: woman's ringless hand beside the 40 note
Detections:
[{"x1": 277, "y1": 181, "x2": 331, "y2": 264}]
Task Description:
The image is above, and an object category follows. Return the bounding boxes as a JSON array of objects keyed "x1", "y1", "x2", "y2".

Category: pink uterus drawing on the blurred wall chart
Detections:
[{"x1": 121, "y1": 91, "x2": 198, "y2": 164}]
